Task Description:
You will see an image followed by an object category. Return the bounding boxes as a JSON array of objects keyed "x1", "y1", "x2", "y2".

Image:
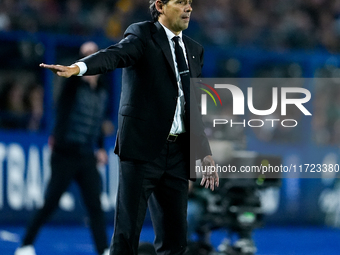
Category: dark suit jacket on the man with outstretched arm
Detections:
[{"x1": 80, "y1": 22, "x2": 211, "y2": 161}]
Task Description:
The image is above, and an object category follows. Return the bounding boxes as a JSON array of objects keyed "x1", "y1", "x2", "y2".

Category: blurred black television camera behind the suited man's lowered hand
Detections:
[{"x1": 187, "y1": 151, "x2": 281, "y2": 255}]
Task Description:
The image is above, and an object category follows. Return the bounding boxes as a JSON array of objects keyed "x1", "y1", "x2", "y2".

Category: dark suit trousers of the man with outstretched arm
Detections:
[{"x1": 110, "y1": 134, "x2": 189, "y2": 255}]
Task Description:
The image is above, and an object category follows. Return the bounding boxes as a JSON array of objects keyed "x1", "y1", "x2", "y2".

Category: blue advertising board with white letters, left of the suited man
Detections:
[{"x1": 0, "y1": 132, "x2": 118, "y2": 224}]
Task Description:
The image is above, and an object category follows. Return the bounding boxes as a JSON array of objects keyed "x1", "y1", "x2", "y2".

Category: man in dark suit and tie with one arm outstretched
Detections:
[{"x1": 40, "y1": 0, "x2": 219, "y2": 255}]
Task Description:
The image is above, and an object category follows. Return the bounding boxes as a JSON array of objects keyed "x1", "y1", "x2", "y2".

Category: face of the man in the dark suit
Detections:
[{"x1": 156, "y1": 0, "x2": 192, "y2": 35}]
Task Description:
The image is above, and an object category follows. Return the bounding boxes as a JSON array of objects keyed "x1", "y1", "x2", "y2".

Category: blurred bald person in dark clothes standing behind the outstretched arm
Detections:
[{"x1": 15, "y1": 42, "x2": 109, "y2": 255}]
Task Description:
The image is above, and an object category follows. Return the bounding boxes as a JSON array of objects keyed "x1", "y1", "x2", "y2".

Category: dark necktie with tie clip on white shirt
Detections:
[{"x1": 172, "y1": 36, "x2": 190, "y2": 127}]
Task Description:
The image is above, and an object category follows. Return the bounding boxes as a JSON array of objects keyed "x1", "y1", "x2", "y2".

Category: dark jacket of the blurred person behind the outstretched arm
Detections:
[{"x1": 52, "y1": 76, "x2": 109, "y2": 154}]
